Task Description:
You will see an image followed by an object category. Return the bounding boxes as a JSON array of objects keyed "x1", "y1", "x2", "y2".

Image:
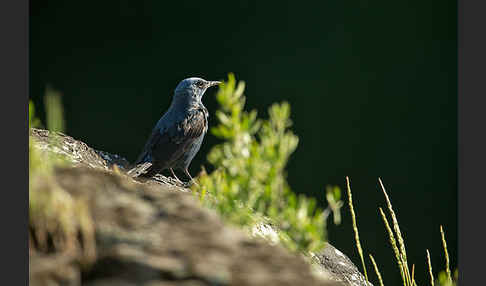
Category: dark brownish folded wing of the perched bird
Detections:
[{"x1": 132, "y1": 108, "x2": 207, "y2": 174}]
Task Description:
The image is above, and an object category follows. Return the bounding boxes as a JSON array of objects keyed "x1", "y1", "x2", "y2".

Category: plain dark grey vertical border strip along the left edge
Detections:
[{"x1": 0, "y1": 0, "x2": 29, "y2": 285}]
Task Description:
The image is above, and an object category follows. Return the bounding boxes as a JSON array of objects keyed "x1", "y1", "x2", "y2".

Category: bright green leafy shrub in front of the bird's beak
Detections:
[{"x1": 194, "y1": 74, "x2": 342, "y2": 252}]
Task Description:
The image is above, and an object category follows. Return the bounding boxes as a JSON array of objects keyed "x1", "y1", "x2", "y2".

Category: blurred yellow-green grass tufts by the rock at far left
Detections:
[{"x1": 29, "y1": 89, "x2": 96, "y2": 265}]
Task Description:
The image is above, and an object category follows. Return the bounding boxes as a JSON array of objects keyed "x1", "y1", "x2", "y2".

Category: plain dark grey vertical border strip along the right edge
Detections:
[{"x1": 458, "y1": 0, "x2": 486, "y2": 285}]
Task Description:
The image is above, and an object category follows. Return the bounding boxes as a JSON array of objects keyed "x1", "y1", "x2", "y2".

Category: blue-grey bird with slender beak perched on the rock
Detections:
[{"x1": 128, "y1": 77, "x2": 221, "y2": 184}]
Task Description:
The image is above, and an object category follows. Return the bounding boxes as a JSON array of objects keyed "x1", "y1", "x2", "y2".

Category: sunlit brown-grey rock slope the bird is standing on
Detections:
[{"x1": 29, "y1": 129, "x2": 366, "y2": 286}]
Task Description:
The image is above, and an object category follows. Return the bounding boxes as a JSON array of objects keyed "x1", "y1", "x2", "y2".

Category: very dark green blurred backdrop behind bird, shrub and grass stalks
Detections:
[{"x1": 30, "y1": 0, "x2": 457, "y2": 285}]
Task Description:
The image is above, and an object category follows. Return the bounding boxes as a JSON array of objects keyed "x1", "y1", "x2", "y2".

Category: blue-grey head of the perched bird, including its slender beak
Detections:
[{"x1": 174, "y1": 77, "x2": 221, "y2": 104}]
